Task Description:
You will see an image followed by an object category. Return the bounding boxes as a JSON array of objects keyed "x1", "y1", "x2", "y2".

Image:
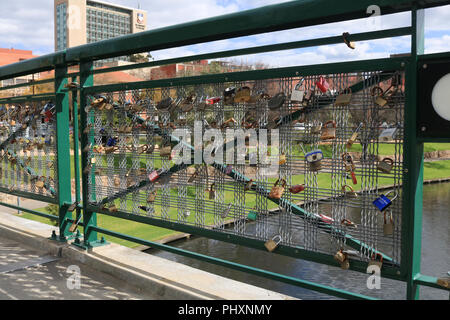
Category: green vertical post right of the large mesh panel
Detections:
[{"x1": 402, "y1": 9, "x2": 425, "y2": 300}]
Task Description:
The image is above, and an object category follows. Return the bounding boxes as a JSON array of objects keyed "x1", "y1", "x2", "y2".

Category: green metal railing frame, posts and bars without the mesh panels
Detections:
[{"x1": 0, "y1": 0, "x2": 450, "y2": 299}]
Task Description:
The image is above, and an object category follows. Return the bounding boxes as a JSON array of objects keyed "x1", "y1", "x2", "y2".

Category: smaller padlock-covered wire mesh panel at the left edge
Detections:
[{"x1": 0, "y1": 102, "x2": 58, "y2": 198}]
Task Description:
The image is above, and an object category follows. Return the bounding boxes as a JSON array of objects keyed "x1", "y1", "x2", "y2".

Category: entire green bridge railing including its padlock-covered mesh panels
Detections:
[{"x1": 0, "y1": 0, "x2": 448, "y2": 299}]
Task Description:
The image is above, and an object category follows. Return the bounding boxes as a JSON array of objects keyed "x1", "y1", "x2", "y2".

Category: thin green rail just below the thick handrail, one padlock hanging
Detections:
[{"x1": 89, "y1": 27, "x2": 411, "y2": 74}]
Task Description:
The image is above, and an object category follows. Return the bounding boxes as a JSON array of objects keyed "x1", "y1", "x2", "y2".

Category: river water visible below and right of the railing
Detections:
[{"x1": 151, "y1": 183, "x2": 450, "y2": 300}]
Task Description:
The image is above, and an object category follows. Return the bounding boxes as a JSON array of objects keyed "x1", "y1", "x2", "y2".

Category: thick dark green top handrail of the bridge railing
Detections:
[{"x1": 0, "y1": 0, "x2": 448, "y2": 80}]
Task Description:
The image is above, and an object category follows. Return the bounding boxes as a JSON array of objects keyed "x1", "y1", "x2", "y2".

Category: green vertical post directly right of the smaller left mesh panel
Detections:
[{"x1": 55, "y1": 66, "x2": 72, "y2": 241}]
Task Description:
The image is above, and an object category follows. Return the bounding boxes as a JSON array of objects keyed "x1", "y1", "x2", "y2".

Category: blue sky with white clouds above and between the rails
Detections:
[{"x1": 0, "y1": 0, "x2": 450, "y2": 67}]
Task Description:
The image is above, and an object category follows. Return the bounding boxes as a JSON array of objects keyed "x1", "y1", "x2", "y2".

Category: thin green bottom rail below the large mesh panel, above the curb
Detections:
[{"x1": 91, "y1": 227, "x2": 376, "y2": 300}]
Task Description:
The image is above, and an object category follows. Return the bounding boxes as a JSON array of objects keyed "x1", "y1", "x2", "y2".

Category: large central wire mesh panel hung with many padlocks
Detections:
[{"x1": 84, "y1": 72, "x2": 405, "y2": 265}]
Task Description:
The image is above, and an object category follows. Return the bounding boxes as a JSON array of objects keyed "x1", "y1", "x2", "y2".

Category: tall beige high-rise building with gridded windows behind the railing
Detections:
[{"x1": 55, "y1": 0, "x2": 147, "y2": 62}]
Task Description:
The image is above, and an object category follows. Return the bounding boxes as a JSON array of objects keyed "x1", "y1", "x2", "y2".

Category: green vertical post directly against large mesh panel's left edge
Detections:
[{"x1": 80, "y1": 61, "x2": 97, "y2": 247}]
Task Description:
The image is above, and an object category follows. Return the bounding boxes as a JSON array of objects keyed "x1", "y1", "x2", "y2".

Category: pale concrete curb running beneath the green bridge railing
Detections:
[{"x1": 0, "y1": 213, "x2": 294, "y2": 300}]
